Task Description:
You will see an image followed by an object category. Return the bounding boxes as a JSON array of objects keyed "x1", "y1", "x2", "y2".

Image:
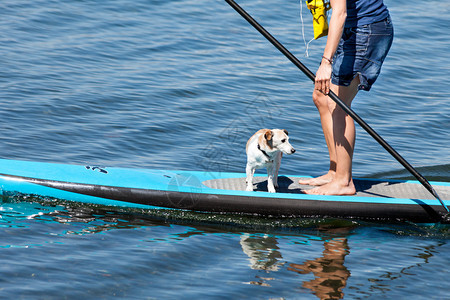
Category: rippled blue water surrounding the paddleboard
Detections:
[{"x1": 0, "y1": 0, "x2": 450, "y2": 299}]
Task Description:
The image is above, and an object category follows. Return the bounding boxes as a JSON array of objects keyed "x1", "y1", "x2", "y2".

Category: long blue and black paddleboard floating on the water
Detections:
[{"x1": 0, "y1": 160, "x2": 450, "y2": 222}]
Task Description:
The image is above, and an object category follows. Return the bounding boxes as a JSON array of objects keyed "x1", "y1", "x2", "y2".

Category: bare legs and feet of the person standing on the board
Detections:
[{"x1": 300, "y1": 76, "x2": 359, "y2": 195}]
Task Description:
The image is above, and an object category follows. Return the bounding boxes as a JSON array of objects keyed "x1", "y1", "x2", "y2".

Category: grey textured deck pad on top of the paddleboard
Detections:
[{"x1": 202, "y1": 176, "x2": 450, "y2": 200}]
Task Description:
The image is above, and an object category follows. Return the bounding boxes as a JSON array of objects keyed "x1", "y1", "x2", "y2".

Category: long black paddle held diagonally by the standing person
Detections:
[{"x1": 225, "y1": 0, "x2": 450, "y2": 214}]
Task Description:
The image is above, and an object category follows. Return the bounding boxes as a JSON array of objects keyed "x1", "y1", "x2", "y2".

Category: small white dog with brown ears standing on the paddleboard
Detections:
[{"x1": 245, "y1": 129, "x2": 295, "y2": 193}]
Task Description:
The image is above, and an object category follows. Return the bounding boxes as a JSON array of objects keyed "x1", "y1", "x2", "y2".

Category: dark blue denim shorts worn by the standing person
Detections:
[{"x1": 331, "y1": 17, "x2": 394, "y2": 91}]
